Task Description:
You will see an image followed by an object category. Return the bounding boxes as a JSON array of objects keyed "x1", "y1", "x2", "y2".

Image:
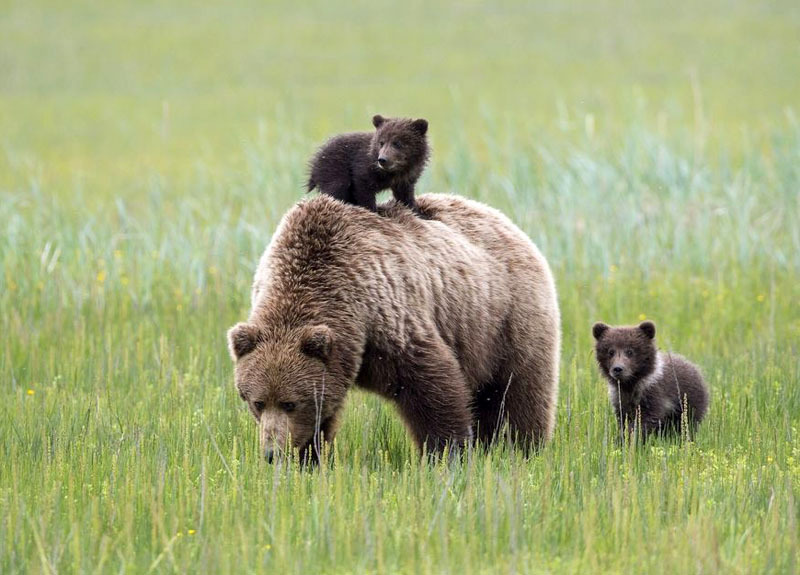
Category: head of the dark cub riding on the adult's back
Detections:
[{"x1": 372, "y1": 114, "x2": 428, "y2": 173}]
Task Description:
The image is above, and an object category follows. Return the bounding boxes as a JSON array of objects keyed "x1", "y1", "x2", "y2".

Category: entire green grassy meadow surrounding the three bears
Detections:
[{"x1": 0, "y1": 0, "x2": 800, "y2": 574}]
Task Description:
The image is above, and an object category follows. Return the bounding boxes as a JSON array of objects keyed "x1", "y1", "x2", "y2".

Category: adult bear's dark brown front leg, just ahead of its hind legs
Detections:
[{"x1": 395, "y1": 338, "x2": 472, "y2": 454}]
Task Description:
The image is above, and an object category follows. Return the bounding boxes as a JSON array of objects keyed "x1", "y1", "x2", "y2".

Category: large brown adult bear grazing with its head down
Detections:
[{"x1": 229, "y1": 195, "x2": 560, "y2": 458}]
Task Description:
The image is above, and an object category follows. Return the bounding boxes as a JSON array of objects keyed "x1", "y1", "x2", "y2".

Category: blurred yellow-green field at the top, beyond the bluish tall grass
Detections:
[{"x1": 0, "y1": 0, "x2": 800, "y2": 195}]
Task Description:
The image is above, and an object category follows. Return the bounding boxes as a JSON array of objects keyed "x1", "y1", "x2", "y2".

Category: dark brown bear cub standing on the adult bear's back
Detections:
[{"x1": 307, "y1": 115, "x2": 429, "y2": 213}]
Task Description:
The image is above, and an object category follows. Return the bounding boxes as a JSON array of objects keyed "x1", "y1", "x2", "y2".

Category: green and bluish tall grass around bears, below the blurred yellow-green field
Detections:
[{"x1": 0, "y1": 120, "x2": 800, "y2": 573}]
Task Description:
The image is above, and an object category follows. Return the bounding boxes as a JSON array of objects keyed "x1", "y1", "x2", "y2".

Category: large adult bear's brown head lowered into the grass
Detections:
[{"x1": 228, "y1": 323, "x2": 347, "y2": 461}]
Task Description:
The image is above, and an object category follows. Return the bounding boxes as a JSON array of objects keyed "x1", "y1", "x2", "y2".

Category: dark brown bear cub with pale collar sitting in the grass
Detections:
[{"x1": 592, "y1": 321, "x2": 709, "y2": 439}]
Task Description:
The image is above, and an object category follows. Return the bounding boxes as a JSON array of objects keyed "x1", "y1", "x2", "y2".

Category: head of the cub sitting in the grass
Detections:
[{"x1": 592, "y1": 321, "x2": 658, "y2": 388}]
